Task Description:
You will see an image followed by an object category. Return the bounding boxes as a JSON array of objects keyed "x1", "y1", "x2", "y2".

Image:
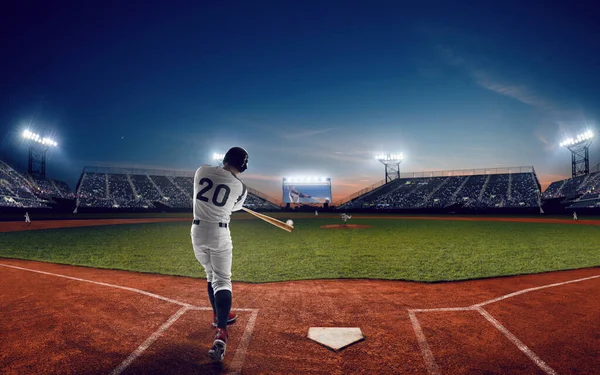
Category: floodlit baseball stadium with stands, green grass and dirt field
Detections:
[{"x1": 0, "y1": 131, "x2": 600, "y2": 374}]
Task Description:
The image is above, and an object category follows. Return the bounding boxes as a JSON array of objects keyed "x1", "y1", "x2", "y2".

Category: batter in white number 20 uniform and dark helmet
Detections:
[{"x1": 191, "y1": 147, "x2": 248, "y2": 362}]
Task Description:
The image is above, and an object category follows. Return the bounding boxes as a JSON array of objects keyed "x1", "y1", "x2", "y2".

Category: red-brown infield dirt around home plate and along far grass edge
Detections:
[{"x1": 0, "y1": 217, "x2": 600, "y2": 375}]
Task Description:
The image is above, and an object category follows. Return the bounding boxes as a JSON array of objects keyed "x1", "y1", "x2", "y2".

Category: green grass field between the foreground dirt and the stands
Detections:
[{"x1": 0, "y1": 218, "x2": 600, "y2": 282}]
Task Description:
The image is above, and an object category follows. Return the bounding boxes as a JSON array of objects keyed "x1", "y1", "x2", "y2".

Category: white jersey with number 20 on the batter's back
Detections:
[{"x1": 193, "y1": 165, "x2": 248, "y2": 223}]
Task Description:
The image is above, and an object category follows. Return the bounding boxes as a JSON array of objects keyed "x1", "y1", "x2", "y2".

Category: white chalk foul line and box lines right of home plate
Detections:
[{"x1": 408, "y1": 275, "x2": 600, "y2": 375}]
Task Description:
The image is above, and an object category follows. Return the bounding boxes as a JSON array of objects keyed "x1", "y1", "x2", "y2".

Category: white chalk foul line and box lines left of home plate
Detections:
[{"x1": 0, "y1": 263, "x2": 260, "y2": 375}]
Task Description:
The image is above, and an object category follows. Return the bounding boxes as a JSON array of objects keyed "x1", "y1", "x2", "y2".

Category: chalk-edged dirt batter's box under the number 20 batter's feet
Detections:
[{"x1": 112, "y1": 306, "x2": 258, "y2": 375}]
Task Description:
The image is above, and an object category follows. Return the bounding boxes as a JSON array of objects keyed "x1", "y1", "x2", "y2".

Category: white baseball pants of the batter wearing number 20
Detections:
[{"x1": 191, "y1": 222, "x2": 233, "y2": 293}]
